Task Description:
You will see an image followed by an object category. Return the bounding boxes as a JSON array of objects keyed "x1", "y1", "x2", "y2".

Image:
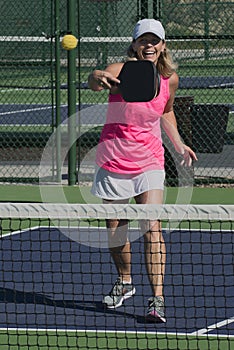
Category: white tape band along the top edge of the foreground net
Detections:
[{"x1": 0, "y1": 203, "x2": 234, "y2": 221}]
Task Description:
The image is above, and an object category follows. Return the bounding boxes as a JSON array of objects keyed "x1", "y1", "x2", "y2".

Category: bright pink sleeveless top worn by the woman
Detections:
[{"x1": 96, "y1": 76, "x2": 170, "y2": 174}]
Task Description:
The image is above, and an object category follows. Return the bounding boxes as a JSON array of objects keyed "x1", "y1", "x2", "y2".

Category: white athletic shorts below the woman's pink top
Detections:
[{"x1": 91, "y1": 168, "x2": 165, "y2": 200}]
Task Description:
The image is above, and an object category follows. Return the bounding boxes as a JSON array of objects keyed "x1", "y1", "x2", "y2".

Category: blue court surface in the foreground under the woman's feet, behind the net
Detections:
[{"x1": 0, "y1": 227, "x2": 234, "y2": 338}]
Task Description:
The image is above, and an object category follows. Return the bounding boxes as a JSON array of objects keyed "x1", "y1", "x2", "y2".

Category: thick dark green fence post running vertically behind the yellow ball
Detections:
[{"x1": 67, "y1": 0, "x2": 77, "y2": 186}]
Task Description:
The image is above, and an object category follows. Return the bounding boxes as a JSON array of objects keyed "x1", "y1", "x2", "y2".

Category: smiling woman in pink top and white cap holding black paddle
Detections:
[{"x1": 89, "y1": 19, "x2": 197, "y2": 322}]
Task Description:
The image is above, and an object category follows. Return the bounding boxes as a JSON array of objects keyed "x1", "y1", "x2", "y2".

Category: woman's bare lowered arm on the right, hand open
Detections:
[{"x1": 161, "y1": 73, "x2": 197, "y2": 166}]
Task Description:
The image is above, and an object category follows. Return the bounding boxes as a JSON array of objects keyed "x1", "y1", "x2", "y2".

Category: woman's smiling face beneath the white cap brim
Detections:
[{"x1": 132, "y1": 33, "x2": 165, "y2": 64}]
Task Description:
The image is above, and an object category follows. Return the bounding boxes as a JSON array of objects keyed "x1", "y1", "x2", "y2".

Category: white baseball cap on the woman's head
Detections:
[{"x1": 132, "y1": 18, "x2": 165, "y2": 40}]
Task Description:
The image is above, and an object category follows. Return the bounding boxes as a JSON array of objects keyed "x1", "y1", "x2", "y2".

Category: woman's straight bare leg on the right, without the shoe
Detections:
[{"x1": 135, "y1": 190, "x2": 166, "y2": 296}]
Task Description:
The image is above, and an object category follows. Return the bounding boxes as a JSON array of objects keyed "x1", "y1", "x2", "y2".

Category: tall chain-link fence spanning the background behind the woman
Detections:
[{"x1": 0, "y1": 0, "x2": 234, "y2": 184}]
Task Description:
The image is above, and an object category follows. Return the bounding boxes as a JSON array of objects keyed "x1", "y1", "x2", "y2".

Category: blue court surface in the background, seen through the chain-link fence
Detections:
[{"x1": 0, "y1": 76, "x2": 234, "y2": 125}]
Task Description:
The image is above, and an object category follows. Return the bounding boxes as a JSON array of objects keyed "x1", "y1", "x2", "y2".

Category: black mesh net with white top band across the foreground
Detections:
[{"x1": 0, "y1": 203, "x2": 234, "y2": 350}]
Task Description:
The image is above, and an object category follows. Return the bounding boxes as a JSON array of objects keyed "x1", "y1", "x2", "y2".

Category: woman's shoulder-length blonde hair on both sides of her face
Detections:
[{"x1": 127, "y1": 44, "x2": 177, "y2": 78}]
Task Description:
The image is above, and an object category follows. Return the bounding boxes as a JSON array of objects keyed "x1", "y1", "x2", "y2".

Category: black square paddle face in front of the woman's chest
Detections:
[{"x1": 118, "y1": 61, "x2": 160, "y2": 102}]
